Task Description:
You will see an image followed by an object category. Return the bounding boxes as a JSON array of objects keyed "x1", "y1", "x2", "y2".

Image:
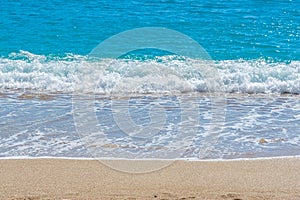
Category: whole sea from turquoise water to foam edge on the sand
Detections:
[{"x1": 0, "y1": 0, "x2": 300, "y2": 160}]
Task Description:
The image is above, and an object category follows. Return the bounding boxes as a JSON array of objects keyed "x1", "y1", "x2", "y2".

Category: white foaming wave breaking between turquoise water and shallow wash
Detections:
[{"x1": 0, "y1": 51, "x2": 300, "y2": 94}]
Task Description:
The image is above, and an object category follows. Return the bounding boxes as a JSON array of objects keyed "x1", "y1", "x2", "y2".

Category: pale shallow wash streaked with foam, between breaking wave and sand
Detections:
[{"x1": 0, "y1": 93, "x2": 300, "y2": 159}]
